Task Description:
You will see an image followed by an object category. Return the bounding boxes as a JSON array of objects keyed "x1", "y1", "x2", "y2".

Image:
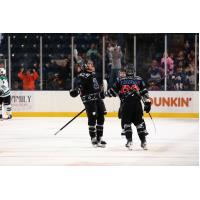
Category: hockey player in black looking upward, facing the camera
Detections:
[{"x1": 70, "y1": 60, "x2": 106, "y2": 147}]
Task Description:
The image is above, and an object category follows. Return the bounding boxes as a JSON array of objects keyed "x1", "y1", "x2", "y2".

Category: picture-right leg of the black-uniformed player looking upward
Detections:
[{"x1": 96, "y1": 99, "x2": 106, "y2": 147}]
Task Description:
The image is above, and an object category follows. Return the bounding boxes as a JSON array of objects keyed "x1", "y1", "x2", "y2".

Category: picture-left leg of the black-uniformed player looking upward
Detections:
[{"x1": 85, "y1": 102, "x2": 97, "y2": 146}]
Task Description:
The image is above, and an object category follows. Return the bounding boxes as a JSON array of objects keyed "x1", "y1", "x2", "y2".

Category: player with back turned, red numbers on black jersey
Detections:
[{"x1": 107, "y1": 67, "x2": 151, "y2": 150}]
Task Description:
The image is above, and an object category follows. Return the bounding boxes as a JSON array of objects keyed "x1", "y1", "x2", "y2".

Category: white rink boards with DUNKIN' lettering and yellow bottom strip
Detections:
[{"x1": 12, "y1": 91, "x2": 199, "y2": 118}]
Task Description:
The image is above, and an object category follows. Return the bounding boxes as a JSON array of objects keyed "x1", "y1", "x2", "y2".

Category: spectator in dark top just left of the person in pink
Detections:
[{"x1": 148, "y1": 59, "x2": 164, "y2": 85}]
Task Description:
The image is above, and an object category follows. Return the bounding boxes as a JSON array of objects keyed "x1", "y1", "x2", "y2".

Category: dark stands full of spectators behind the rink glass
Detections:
[{"x1": 0, "y1": 33, "x2": 199, "y2": 91}]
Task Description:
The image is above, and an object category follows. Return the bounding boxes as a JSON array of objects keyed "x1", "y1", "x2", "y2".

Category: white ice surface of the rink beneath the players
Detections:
[{"x1": 0, "y1": 118, "x2": 199, "y2": 166}]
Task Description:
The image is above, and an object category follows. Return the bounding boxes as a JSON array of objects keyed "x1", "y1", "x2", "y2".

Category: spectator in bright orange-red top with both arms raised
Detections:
[{"x1": 18, "y1": 68, "x2": 39, "y2": 90}]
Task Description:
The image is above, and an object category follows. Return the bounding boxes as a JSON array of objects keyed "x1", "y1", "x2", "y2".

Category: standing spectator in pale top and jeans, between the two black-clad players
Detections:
[{"x1": 108, "y1": 41, "x2": 122, "y2": 86}]
